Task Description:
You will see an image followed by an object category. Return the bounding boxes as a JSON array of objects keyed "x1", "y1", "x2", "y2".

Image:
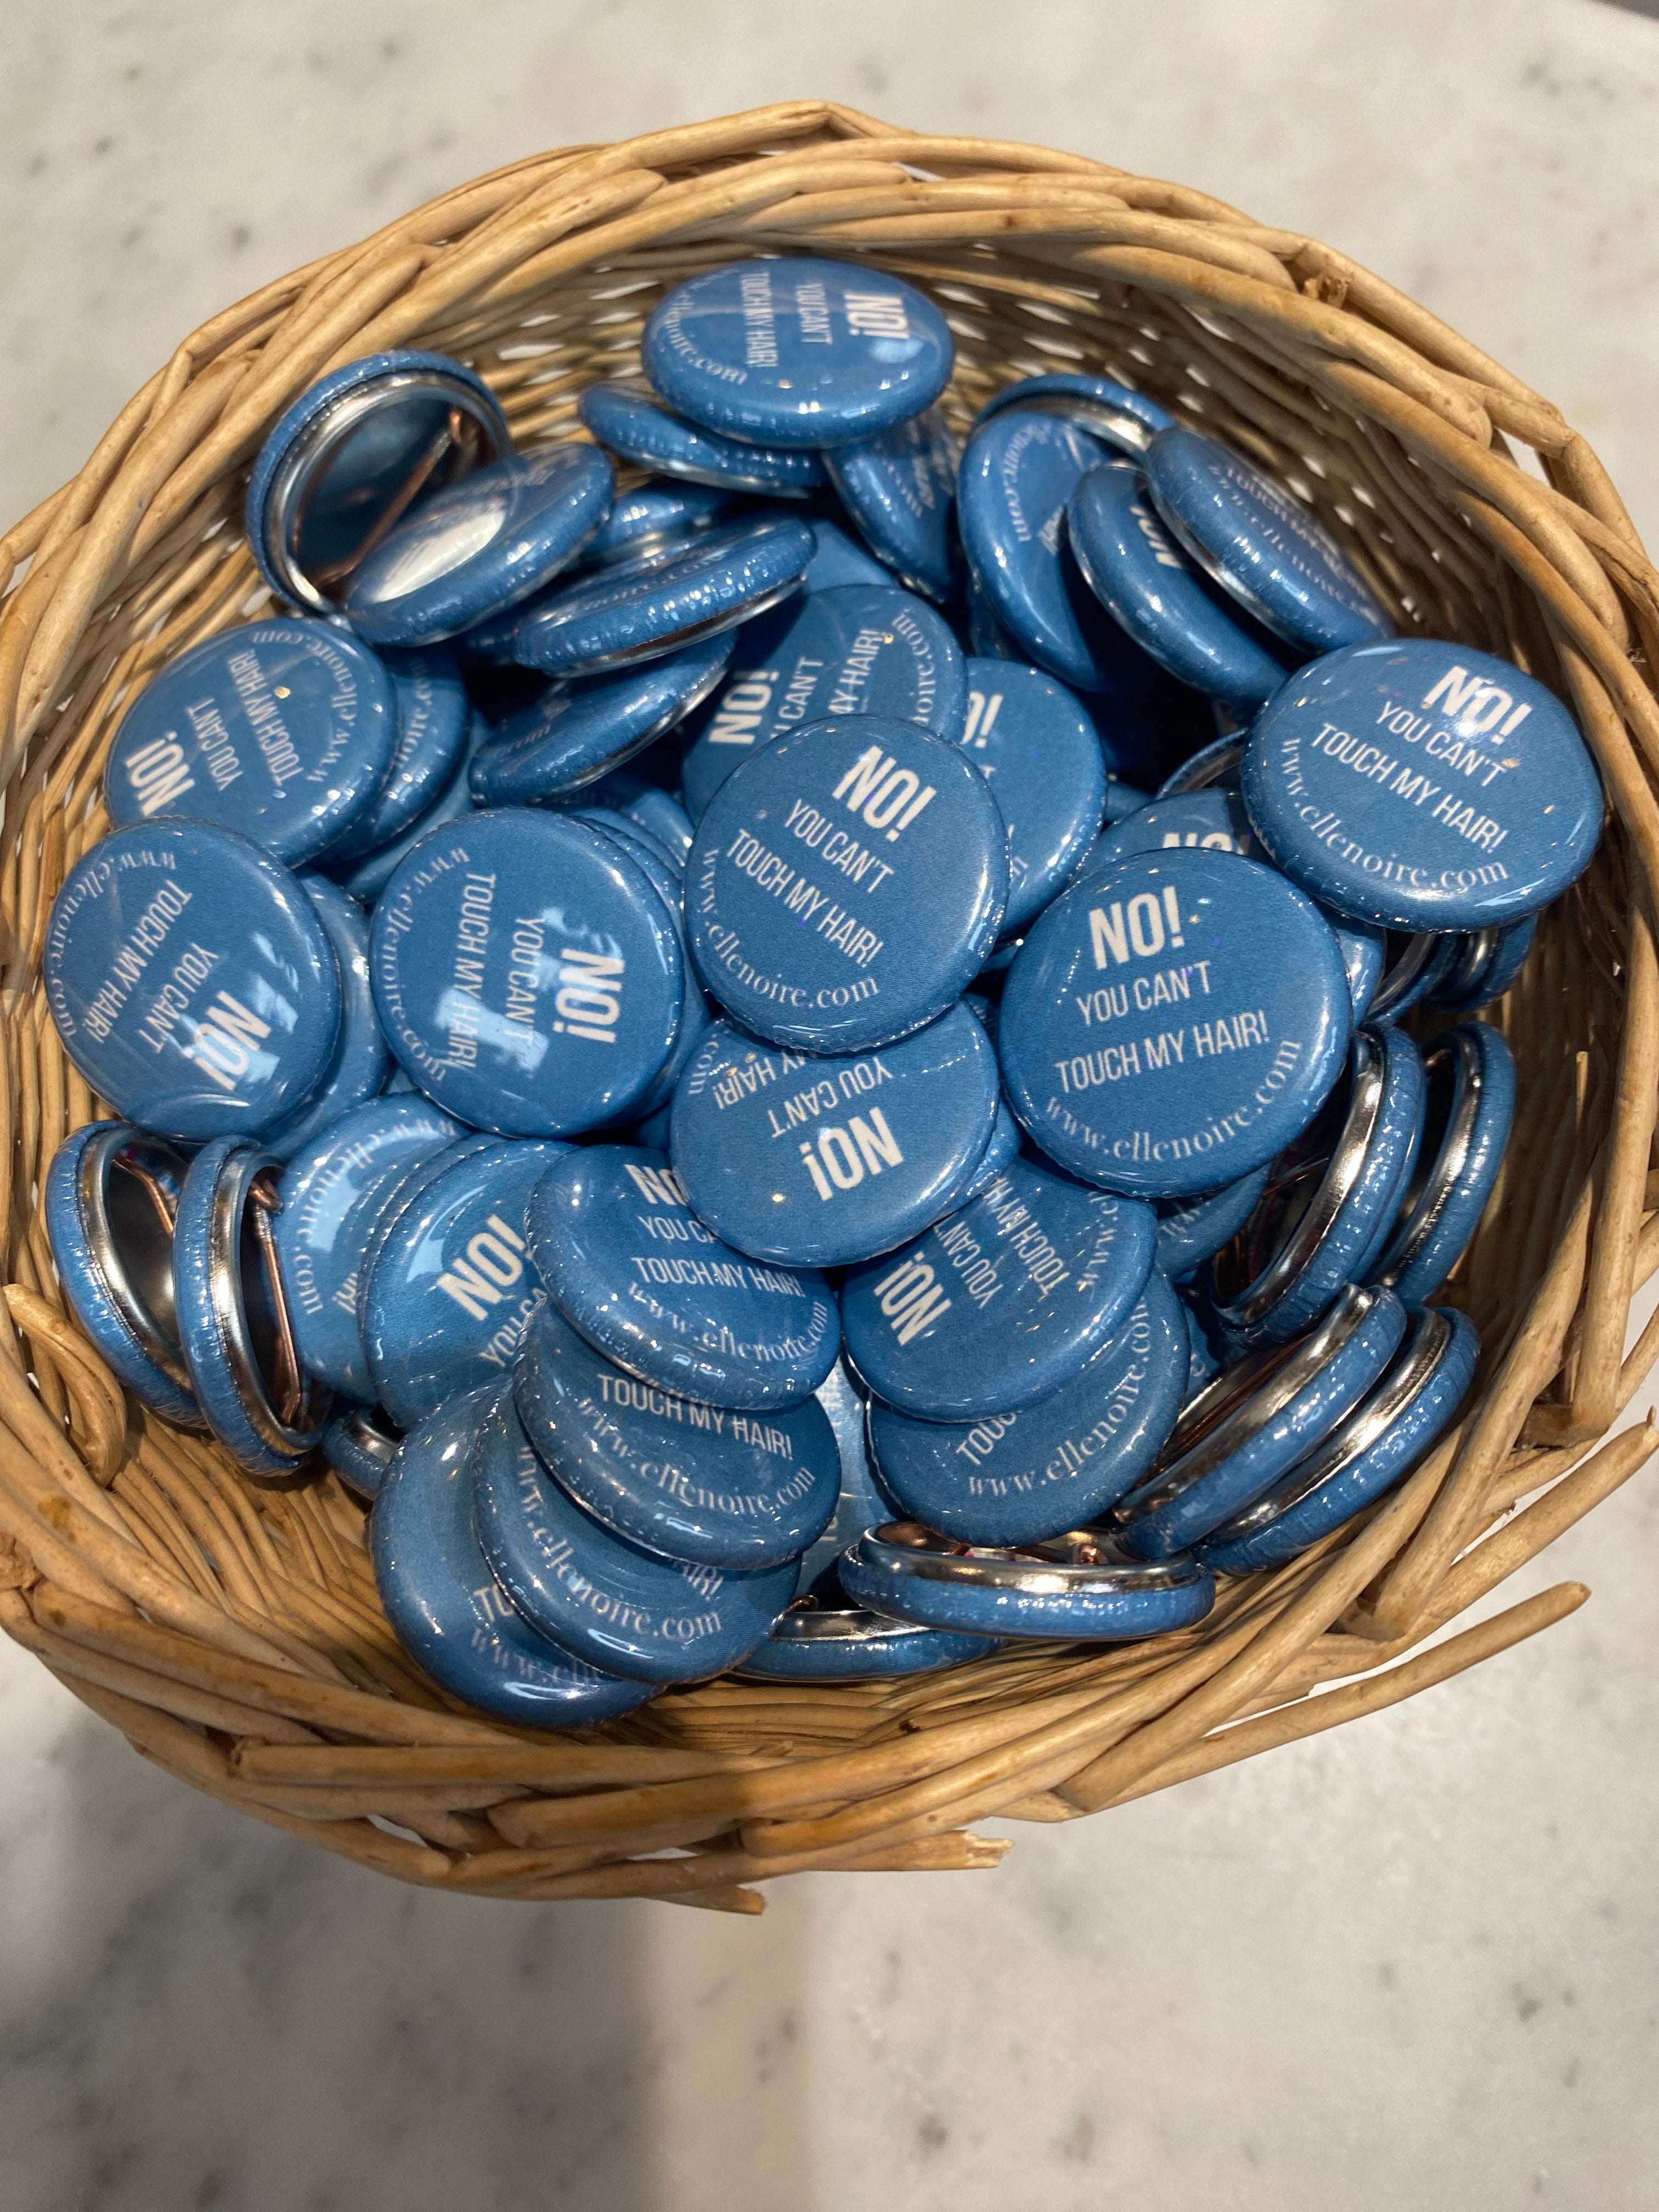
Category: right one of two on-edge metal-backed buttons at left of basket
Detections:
[{"x1": 172, "y1": 1137, "x2": 328, "y2": 1475}]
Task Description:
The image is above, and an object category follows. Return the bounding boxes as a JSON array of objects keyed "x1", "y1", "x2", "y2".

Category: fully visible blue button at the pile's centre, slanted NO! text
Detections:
[{"x1": 686, "y1": 714, "x2": 1009, "y2": 1053}]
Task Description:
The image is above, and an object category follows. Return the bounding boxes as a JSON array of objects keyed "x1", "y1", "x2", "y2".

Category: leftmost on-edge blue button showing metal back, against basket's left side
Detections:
[{"x1": 42, "y1": 1121, "x2": 204, "y2": 1429}]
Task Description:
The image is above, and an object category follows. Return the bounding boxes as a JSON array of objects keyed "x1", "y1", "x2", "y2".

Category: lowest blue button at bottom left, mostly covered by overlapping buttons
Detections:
[{"x1": 369, "y1": 1389, "x2": 650, "y2": 1728}]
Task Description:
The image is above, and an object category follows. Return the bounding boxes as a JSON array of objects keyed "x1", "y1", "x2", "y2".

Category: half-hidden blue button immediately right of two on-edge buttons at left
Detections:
[{"x1": 274, "y1": 1091, "x2": 460, "y2": 1398}]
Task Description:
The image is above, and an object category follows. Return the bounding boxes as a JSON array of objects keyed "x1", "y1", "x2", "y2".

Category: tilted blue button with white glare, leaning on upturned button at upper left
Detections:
[{"x1": 341, "y1": 438, "x2": 617, "y2": 646}]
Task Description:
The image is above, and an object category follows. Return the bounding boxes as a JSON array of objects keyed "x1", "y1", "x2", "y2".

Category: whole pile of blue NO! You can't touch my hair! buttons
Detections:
[{"x1": 44, "y1": 259, "x2": 1601, "y2": 1728}]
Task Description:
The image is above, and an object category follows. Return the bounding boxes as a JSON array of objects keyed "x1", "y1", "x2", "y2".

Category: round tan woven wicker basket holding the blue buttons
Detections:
[{"x1": 0, "y1": 101, "x2": 1659, "y2": 1911}]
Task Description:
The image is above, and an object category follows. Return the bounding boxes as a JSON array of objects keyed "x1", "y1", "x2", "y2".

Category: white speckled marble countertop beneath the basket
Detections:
[{"x1": 0, "y1": 0, "x2": 1659, "y2": 2212}]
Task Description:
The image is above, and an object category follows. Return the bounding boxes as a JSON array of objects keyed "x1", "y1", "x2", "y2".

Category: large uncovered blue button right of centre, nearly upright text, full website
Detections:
[{"x1": 997, "y1": 849, "x2": 1350, "y2": 1199}]
